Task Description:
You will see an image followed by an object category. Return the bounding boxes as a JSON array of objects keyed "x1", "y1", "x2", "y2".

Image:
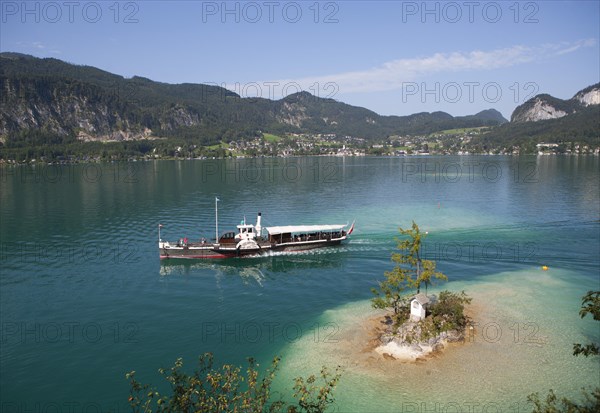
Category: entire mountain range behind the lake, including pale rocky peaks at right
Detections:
[{"x1": 0, "y1": 52, "x2": 600, "y2": 151}]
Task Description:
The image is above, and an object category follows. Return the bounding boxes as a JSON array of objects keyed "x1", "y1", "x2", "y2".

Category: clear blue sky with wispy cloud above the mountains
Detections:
[{"x1": 0, "y1": 0, "x2": 600, "y2": 119}]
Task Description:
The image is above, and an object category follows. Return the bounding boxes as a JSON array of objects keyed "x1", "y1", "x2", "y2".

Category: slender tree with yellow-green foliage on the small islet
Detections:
[{"x1": 371, "y1": 221, "x2": 448, "y2": 317}]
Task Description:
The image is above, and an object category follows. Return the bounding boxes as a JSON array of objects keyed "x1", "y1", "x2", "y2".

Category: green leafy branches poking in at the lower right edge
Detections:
[{"x1": 527, "y1": 291, "x2": 600, "y2": 413}]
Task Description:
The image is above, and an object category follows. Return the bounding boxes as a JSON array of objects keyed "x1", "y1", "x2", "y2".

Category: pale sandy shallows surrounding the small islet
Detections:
[{"x1": 281, "y1": 270, "x2": 597, "y2": 412}]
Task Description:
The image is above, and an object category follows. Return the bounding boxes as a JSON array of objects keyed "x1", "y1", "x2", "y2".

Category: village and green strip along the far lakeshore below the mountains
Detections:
[{"x1": 0, "y1": 127, "x2": 600, "y2": 165}]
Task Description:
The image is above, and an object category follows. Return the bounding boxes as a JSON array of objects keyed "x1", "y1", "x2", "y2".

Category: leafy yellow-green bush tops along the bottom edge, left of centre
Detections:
[{"x1": 125, "y1": 353, "x2": 341, "y2": 413}]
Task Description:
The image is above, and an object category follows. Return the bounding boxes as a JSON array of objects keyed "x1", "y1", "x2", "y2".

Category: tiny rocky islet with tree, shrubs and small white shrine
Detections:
[{"x1": 372, "y1": 222, "x2": 473, "y2": 361}]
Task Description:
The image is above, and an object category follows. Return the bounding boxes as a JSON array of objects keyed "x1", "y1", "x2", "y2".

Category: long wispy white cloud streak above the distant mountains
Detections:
[{"x1": 268, "y1": 39, "x2": 596, "y2": 93}]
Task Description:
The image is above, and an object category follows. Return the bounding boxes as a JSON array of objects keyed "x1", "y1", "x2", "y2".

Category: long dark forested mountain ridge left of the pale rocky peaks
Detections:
[{"x1": 0, "y1": 53, "x2": 507, "y2": 144}]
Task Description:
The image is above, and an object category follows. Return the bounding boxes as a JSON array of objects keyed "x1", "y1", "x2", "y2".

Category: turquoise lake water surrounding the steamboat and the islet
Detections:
[{"x1": 0, "y1": 156, "x2": 600, "y2": 412}]
